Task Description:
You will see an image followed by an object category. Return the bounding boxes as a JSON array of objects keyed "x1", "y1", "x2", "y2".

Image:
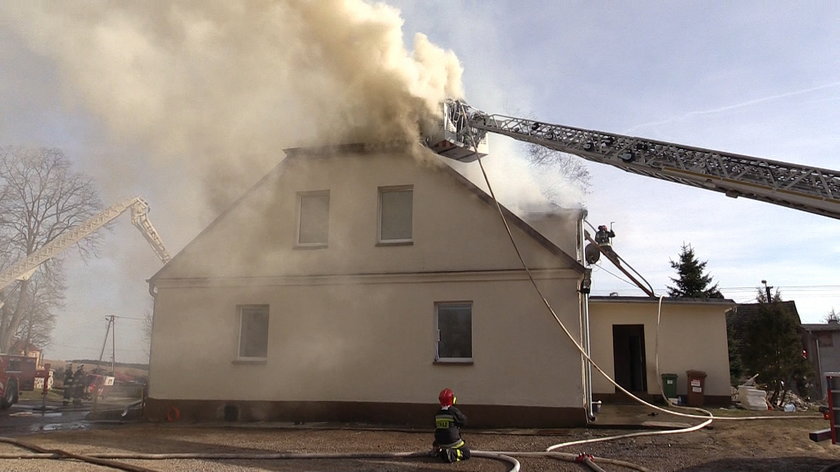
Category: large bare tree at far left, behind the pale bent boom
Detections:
[{"x1": 0, "y1": 147, "x2": 102, "y2": 352}]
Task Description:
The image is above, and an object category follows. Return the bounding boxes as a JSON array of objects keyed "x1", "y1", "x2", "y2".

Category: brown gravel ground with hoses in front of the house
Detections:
[{"x1": 0, "y1": 419, "x2": 840, "y2": 472}]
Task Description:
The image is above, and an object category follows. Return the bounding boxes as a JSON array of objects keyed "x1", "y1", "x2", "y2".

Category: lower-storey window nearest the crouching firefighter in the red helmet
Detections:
[{"x1": 435, "y1": 302, "x2": 472, "y2": 362}]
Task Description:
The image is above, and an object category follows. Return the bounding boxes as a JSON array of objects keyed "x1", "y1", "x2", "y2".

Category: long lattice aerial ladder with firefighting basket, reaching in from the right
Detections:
[{"x1": 428, "y1": 100, "x2": 840, "y2": 219}]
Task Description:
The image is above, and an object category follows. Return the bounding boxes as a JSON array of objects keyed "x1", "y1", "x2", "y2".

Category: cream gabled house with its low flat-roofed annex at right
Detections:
[{"x1": 146, "y1": 145, "x2": 728, "y2": 427}]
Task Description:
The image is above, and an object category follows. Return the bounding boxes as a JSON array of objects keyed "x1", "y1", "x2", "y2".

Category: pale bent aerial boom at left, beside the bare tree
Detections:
[{"x1": 0, "y1": 197, "x2": 172, "y2": 292}]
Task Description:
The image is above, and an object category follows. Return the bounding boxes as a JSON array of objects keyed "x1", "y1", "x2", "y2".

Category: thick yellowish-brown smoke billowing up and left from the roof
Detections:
[{"x1": 0, "y1": 0, "x2": 463, "y2": 210}]
